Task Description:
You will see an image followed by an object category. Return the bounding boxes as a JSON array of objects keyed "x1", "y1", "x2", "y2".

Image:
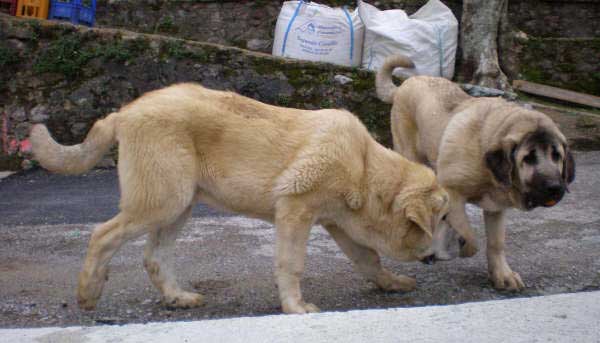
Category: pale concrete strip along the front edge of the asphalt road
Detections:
[{"x1": 0, "y1": 292, "x2": 600, "y2": 343}]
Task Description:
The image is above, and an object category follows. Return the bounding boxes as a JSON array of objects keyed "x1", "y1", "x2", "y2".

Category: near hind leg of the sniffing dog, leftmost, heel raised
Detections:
[{"x1": 77, "y1": 212, "x2": 151, "y2": 310}]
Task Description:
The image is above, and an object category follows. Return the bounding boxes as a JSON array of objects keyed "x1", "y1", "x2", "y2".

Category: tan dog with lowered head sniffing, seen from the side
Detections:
[{"x1": 31, "y1": 84, "x2": 448, "y2": 313}]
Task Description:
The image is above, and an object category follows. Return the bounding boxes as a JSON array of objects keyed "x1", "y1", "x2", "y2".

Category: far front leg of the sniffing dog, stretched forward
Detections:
[{"x1": 325, "y1": 225, "x2": 416, "y2": 292}]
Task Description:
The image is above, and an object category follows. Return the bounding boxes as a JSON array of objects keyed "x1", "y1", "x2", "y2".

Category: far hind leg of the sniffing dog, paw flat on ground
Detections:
[{"x1": 144, "y1": 206, "x2": 203, "y2": 308}]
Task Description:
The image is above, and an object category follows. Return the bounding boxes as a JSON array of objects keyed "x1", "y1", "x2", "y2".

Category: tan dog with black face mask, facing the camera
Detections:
[{"x1": 377, "y1": 56, "x2": 575, "y2": 290}]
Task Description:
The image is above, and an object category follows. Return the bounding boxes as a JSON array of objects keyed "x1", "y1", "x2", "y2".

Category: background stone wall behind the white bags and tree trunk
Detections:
[{"x1": 97, "y1": 0, "x2": 600, "y2": 95}]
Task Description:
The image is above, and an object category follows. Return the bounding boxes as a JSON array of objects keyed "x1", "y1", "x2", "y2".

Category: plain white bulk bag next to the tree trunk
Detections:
[{"x1": 358, "y1": 0, "x2": 458, "y2": 79}]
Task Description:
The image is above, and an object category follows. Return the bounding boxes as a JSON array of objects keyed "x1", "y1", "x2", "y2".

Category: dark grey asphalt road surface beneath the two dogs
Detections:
[{"x1": 0, "y1": 152, "x2": 600, "y2": 328}]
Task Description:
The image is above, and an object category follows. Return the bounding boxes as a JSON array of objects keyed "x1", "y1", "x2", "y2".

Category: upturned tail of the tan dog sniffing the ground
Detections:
[{"x1": 29, "y1": 113, "x2": 116, "y2": 174}]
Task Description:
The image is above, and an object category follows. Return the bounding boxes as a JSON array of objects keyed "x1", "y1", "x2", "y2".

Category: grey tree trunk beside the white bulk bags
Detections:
[{"x1": 460, "y1": 0, "x2": 510, "y2": 90}]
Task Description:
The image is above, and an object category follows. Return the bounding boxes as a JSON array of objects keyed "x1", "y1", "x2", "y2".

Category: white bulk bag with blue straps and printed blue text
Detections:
[{"x1": 273, "y1": 1, "x2": 365, "y2": 66}]
